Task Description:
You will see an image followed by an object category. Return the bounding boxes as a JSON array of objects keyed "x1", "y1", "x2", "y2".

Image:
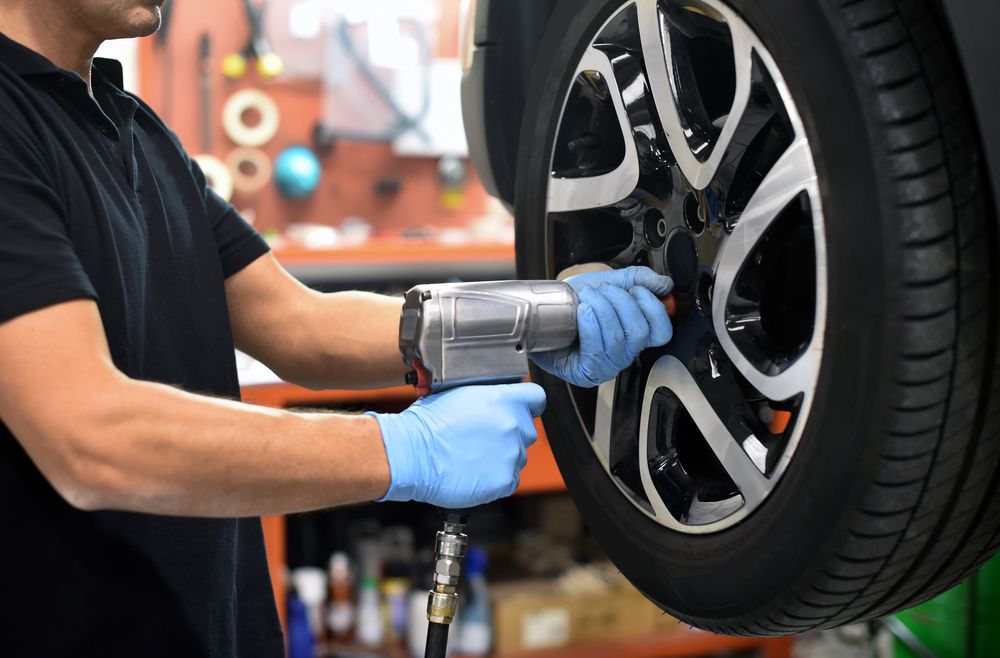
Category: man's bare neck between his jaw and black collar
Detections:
[{"x1": 0, "y1": 0, "x2": 101, "y2": 90}]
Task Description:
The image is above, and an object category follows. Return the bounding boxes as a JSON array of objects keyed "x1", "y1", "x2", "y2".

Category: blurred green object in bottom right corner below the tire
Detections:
[{"x1": 894, "y1": 555, "x2": 1000, "y2": 658}]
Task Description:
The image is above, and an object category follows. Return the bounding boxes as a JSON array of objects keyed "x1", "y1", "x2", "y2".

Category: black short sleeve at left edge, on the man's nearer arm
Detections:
[{"x1": 0, "y1": 119, "x2": 97, "y2": 322}]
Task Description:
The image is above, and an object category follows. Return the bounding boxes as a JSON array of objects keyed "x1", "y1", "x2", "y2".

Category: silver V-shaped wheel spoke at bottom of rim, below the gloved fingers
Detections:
[{"x1": 639, "y1": 356, "x2": 771, "y2": 522}]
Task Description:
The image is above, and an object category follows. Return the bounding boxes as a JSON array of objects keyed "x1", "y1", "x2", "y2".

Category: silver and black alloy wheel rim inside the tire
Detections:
[{"x1": 545, "y1": 0, "x2": 826, "y2": 533}]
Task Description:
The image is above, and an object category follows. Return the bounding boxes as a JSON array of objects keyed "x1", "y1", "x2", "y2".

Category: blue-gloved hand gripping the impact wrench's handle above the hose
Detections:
[{"x1": 369, "y1": 384, "x2": 545, "y2": 508}]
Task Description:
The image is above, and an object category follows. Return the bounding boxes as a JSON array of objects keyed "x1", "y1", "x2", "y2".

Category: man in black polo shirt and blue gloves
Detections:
[{"x1": 0, "y1": 0, "x2": 671, "y2": 658}]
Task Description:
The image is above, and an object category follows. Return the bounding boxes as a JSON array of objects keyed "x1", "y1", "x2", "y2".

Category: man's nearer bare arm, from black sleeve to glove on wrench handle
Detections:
[{"x1": 0, "y1": 300, "x2": 389, "y2": 517}]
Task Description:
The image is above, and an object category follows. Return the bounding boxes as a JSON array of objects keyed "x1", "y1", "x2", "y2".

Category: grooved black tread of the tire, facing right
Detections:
[{"x1": 723, "y1": 0, "x2": 1000, "y2": 635}]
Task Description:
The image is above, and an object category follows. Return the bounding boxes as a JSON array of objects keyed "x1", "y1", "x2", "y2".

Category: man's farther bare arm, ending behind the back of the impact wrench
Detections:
[{"x1": 226, "y1": 254, "x2": 406, "y2": 389}]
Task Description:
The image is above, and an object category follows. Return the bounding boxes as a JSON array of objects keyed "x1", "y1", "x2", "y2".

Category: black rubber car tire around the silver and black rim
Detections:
[{"x1": 515, "y1": 0, "x2": 1000, "y2": 635}]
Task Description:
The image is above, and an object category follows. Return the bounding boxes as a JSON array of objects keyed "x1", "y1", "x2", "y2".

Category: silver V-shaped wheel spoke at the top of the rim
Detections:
[{"x1": 636, "y1": 0, "x2": 753, "y2": 190}]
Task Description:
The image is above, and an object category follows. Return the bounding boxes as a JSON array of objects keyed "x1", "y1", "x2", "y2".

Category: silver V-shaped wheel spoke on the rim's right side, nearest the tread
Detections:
[{"x1": 712, "y1": 139, "x2": 823, "y2": 400}]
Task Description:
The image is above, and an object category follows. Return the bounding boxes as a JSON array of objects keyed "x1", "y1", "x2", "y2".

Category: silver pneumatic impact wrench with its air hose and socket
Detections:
[{"x1": 399, "y1": 281, "x2": 676, "y2": 658}]
